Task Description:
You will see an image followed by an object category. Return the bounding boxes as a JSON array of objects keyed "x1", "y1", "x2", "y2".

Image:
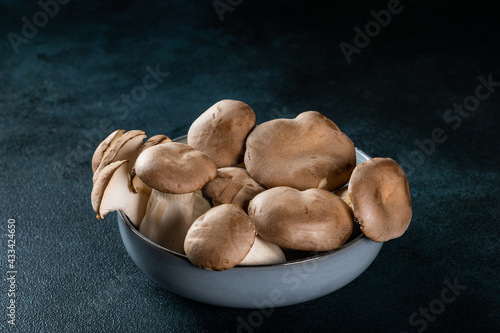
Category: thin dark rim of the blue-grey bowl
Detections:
[{"x1": 118, "y1": 141, "x2": 372, "y2": 270}]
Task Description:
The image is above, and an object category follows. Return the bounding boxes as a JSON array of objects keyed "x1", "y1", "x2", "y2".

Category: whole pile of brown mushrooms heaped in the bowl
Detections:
[{"x1": 91, "y1": 100, "x2": 412, "y2": 271}]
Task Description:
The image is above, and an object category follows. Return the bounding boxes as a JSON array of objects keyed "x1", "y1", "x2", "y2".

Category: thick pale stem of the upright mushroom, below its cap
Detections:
[{"x1": 139, "y1": 189, "x2": 210, "y2": 254}]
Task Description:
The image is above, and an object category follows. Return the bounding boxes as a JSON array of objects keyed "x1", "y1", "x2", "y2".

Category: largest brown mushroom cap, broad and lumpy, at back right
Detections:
[{"x1": 245, "y1": 111, "x2": 356, "y2": 191}]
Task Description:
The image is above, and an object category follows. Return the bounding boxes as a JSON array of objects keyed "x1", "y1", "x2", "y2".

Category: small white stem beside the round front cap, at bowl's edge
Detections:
[{"x1": 238, "y1": 235, "x2": 286, "y2": 266}]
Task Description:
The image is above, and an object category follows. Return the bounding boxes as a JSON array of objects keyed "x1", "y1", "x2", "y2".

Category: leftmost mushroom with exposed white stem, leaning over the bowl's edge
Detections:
[{"x1": 91, "y1": 161, "x2": 149, "y2": 227}]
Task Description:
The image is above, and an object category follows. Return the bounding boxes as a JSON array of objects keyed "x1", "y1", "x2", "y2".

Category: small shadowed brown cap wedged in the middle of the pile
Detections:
[{"x1": 203, "y1": 167, "x2": 265, "y2": 211}]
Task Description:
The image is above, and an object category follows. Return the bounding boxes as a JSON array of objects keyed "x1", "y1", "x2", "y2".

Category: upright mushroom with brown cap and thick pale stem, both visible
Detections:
[{"x1": 135, "y1": 142, "x2": 217, "y2": 253}]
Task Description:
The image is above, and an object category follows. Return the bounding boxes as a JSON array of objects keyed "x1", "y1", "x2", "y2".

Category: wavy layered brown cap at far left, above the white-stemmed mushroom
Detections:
[{"x1": 92, "y1": 130, "x2": 146, "y2": 181}]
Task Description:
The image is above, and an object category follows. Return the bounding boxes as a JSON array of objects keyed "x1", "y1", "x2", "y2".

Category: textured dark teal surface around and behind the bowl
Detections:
[{"x1": 0, "y1": 0, "x2": 500, "y2": 332}]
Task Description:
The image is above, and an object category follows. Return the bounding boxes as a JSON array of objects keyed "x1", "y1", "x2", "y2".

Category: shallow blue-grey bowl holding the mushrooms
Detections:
[{"x1": 118, "y1": 138, "x2": 383, "y2": 308}]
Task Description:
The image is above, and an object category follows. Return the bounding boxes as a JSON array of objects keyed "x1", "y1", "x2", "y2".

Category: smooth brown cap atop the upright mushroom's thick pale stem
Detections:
[{"x1": 135, "y1": 142, "x2": 217, "y2": 194}]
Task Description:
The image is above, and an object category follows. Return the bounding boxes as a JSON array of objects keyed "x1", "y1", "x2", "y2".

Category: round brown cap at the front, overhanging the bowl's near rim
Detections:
[{"x1": 184, "y1": 204, "x2": 255, "y2": 271}]
